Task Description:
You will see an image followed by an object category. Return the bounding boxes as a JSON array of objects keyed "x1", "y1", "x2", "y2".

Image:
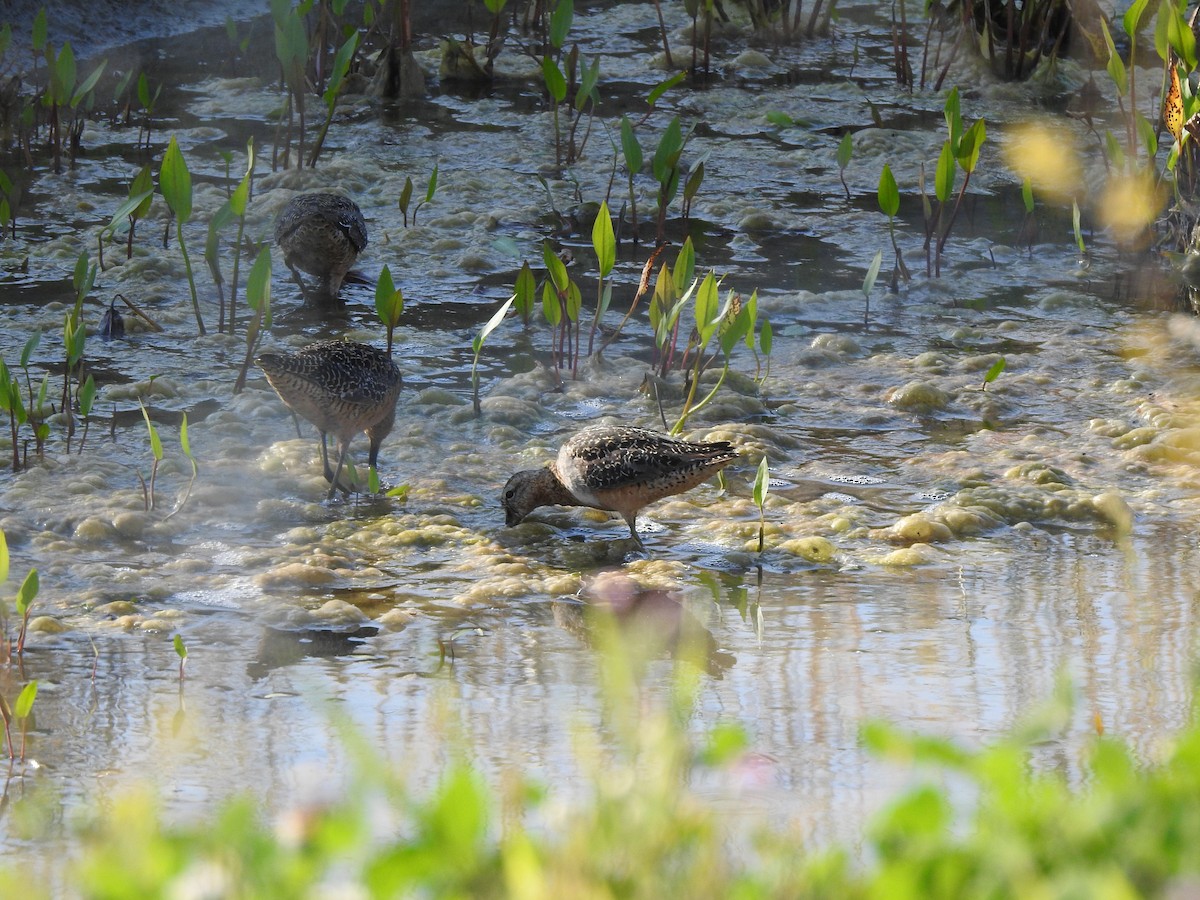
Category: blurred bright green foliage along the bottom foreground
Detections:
[{"x1": 0, "y1": 672, "x2": 1200, "y2": 898}]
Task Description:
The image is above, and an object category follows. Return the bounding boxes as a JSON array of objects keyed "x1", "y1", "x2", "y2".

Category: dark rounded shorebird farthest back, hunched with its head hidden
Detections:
[{"x1": 275, "y1": 193, "x2": 367, "y2": 306}]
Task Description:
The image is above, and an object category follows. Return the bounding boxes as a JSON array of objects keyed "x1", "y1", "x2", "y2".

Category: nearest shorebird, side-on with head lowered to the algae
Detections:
[{"x1": 500, "y1": 425, "x2": 738, "y2": 548}]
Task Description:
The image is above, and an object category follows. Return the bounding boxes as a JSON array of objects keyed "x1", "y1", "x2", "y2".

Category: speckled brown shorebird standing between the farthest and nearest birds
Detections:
[{"x1": 254, "y1": 341, "x2": 400, "y2": 499}]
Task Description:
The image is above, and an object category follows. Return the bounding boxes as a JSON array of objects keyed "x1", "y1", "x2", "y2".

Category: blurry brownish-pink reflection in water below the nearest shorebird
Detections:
[{"x1": 554, "y1": 571, "x2": 737, "y2": 677}]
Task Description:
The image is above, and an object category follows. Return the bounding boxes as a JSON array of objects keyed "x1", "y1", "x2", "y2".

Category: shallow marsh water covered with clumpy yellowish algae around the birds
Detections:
[{"x1": 0, "y1": 2, "x2": 1200, "y2": 873}]
